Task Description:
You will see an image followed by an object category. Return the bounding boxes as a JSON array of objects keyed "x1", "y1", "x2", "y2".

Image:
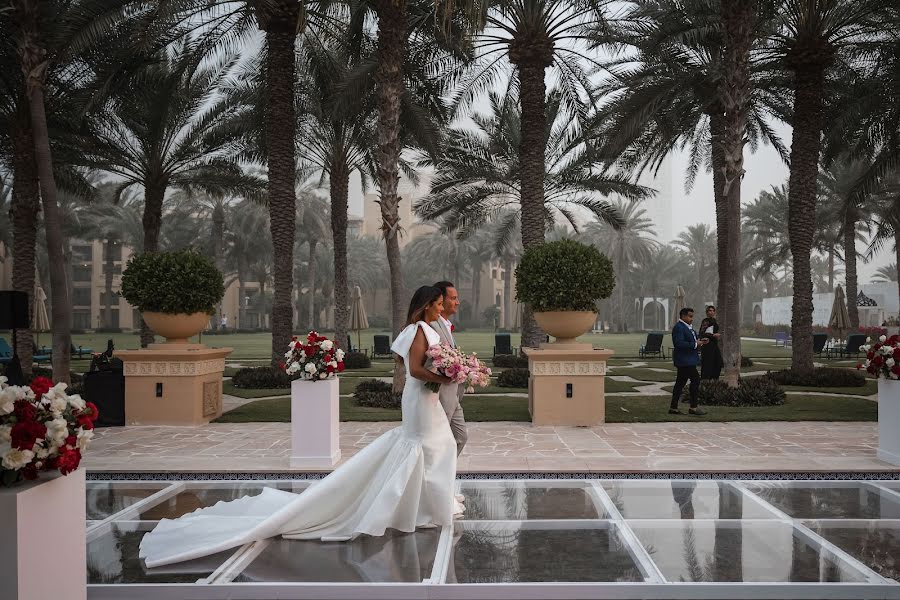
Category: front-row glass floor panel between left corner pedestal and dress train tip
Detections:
[{"x1": 87, "y1": 522, "x2": 234, "y2": 584}]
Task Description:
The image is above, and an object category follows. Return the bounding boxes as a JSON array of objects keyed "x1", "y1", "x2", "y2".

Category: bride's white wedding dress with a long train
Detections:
[{"x1": 140, "y1": 321, "x2": 463, "y2": 568}]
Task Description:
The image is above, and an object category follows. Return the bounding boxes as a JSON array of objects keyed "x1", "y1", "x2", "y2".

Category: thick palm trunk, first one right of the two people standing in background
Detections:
[{"x1": 788, "y1": 62, "x2": 825, "y2": 374}]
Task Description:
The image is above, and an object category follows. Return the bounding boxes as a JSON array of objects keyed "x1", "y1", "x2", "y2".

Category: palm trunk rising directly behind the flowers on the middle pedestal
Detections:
[{"x1": 329, "y1": 161, "x2": 350, "y2": 350}]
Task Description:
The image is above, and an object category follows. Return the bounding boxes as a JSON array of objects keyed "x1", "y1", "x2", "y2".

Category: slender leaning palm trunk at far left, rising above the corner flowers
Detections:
[{"x1": 15, "y1": 5, "x2": 72, "y2": 383}]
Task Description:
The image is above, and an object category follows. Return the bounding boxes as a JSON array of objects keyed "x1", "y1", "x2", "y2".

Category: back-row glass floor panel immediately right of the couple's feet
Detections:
[{"x1": 460, "y1": 481, "x2": 609, "y2": 521}]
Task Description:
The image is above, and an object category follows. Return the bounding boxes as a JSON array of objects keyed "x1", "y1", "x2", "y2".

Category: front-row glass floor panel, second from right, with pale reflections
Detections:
[{"x1": 629, "y1": 521, "x2": 865, "y2": 583}]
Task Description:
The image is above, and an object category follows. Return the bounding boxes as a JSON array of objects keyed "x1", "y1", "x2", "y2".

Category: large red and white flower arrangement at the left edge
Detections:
[{"x1": 0, "y1": 377, "x2": 99, "y2": 485}]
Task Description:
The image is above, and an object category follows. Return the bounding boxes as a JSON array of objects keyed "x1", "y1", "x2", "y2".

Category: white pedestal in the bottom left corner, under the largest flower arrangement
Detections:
[{"x1": 0, "y1": 469, "x2": 87, "y2": 600}]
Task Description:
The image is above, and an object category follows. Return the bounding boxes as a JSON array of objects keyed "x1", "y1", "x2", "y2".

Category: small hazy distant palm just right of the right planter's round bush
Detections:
[{"x1": 583, "y1": 200, "x2": 659, "y2": 332}]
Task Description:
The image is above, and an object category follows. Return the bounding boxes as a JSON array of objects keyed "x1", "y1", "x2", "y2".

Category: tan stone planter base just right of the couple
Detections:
[{"x1": 523, "y1": 344, "x2": 613, "y2": 427}]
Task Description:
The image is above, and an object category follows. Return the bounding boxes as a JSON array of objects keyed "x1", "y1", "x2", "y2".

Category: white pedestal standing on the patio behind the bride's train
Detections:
[{"x1": 291, "y1": 378, "x2": 341, "y2": 469}]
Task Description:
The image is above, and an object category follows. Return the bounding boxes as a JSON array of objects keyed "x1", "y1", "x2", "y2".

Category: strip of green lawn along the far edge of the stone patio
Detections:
[{"x1": 216, "y1": 396, "x2": 878, "y2": 423}]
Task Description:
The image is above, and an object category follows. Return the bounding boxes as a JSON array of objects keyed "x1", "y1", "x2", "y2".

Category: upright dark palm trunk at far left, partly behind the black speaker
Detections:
[{"x1": 10, "y1": 105, "x2": 40, "y2": 378}]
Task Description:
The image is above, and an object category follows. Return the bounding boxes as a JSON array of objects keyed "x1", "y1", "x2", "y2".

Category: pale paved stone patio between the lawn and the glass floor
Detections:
[{"x1": 83, "y1": 422, "x2": 900, "y2": 473}]
